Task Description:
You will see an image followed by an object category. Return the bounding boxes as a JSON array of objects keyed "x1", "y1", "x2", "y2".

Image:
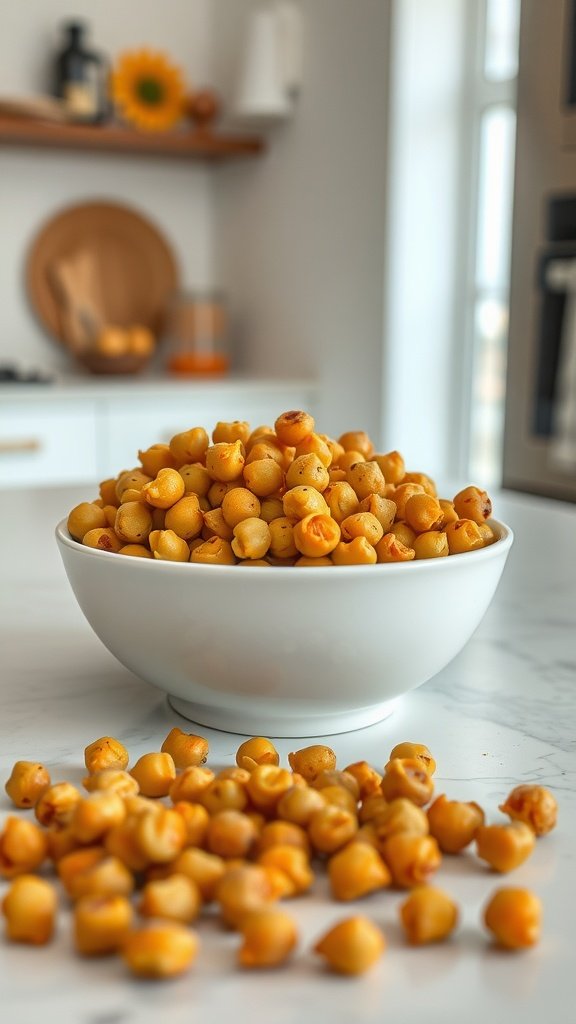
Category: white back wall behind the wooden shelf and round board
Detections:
[{"x1": 0, "y1": 0, "x2": 213, "y2": 367}]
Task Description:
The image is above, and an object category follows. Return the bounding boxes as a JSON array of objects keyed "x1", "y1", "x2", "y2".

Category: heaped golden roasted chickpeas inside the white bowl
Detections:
[{"x1": 68, "y1": 411, "x2": 496, "y2": 566}]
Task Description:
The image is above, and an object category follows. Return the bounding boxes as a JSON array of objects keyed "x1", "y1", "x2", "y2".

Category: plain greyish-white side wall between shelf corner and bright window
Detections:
[{"x1": 212, "y1": 0, "x2": 389, "y2": 437}]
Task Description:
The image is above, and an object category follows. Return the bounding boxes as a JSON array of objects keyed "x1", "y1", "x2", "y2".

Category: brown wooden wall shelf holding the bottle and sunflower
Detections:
[{"x1": 0, "y1": 116, "x2": 264, "y2": 161}]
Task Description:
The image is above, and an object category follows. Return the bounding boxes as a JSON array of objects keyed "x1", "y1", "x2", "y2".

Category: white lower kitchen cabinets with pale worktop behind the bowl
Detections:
[{"x1": 0, "y1": 379, "x2": 318, "y2": 487}]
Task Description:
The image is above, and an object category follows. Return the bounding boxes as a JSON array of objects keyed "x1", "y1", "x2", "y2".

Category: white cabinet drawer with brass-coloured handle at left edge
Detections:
[{"x1": 0, "y1": 401, "x2": 98, "y2": 487}]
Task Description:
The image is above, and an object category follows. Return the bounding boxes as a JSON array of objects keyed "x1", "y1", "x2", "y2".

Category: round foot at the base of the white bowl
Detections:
[{"x1": 168, "y1": 694, "x2": 399, "y2": 738}]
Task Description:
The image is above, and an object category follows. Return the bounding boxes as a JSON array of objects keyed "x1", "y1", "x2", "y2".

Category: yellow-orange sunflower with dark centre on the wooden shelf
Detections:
[{"x1": 111, "y1": 50, "x2": 186, "y2": 131}]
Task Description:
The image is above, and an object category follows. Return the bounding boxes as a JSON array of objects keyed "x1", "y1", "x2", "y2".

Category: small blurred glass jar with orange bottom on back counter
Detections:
[{"x1": 166, "y1": 291, "x2": 230, "y2": 376}]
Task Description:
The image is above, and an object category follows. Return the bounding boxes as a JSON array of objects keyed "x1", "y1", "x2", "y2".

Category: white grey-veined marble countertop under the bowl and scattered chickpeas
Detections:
[{"x1": 0, "y1": 489, "x2": 576, "y2": 1024}]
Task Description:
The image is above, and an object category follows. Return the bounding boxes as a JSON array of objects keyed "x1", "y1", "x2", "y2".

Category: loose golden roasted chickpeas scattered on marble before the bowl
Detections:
[{"x1": 0, "y1": 728, "x2": 557, "y2": 978}]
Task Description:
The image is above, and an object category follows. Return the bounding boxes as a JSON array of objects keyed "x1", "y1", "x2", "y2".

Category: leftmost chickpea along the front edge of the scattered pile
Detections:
[{"x1": 2, "y1": 874, "x2": 56, "y2": 946}]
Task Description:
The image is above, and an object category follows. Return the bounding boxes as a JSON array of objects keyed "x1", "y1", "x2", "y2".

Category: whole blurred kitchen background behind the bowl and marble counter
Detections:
[{"x1": 0, "y1": 0, "x2": 576, "y2": 500}]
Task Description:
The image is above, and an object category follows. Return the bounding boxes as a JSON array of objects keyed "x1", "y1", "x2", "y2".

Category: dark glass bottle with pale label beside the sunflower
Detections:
[{"x1": 55, "y1": 22, "x2": 107, "y2": 124}]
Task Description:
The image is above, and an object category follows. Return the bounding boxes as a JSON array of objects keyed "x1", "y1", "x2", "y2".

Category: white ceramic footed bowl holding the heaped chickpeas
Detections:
[{"x1": 56, "y1": 520, "x2": 512, "y2": 736}]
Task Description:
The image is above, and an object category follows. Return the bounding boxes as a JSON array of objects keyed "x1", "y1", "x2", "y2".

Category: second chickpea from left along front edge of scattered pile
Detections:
[{"x1": 74, "y1": 896, "x2": 133, "y2": 956}]
